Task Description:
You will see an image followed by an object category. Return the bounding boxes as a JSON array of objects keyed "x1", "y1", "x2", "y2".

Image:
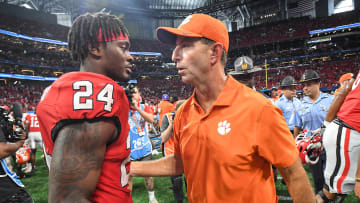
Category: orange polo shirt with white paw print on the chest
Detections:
[{"x1": 174, "y1": 76, "x2": 298, "y2": 203}]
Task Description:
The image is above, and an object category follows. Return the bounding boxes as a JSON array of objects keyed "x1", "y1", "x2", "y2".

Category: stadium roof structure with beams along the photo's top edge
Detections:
[{"x1": 0, "y1": 0, "x2": 352, "y2": 27}]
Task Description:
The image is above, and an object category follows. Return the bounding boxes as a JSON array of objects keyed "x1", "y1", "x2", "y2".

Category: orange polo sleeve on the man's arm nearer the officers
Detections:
[{"x1": 256, "y1": 105, "x2": 299, "y2": 168}]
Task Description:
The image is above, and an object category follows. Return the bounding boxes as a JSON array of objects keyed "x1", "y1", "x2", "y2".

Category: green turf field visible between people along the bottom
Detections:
[{"x1": 21, "y1": 153, "x2": 359, "y2": 203}]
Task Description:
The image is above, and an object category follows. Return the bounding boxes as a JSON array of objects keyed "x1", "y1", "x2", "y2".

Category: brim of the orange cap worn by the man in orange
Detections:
[{"x1": 156, "y1": 27, "x2": 203, "y2": 45}]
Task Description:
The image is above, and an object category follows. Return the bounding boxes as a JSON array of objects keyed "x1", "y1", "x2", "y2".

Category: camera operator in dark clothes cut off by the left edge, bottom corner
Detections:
[{"x1": 0, "y1": 105, "x2": 33, "y2": 203}]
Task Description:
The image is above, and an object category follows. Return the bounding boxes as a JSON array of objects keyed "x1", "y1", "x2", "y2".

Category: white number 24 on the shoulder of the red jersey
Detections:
[{"x1": 73, "y1": 80, "x2": 114, "y2": 112}]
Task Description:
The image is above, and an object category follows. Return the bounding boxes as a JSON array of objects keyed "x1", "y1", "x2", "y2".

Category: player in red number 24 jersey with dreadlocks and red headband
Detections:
[{"x1": 37, "y1": 13, "x2": 133, "y2": 202}]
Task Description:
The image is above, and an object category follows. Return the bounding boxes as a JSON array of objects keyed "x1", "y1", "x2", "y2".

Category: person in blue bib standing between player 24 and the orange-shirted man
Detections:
[{"x1": 129, "y1": 86, "x2": 157, "y2": 203}]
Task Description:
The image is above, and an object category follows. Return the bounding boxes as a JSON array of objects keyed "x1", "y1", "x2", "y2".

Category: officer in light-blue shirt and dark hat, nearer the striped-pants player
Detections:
[{"x1": 294, "y1": 69, "x2": 334, "y2": 193}]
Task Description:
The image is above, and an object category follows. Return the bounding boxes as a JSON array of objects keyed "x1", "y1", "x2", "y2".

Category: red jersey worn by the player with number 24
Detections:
[{"x1": 37, "y1": 72, "x2": 132, "y2": 202}]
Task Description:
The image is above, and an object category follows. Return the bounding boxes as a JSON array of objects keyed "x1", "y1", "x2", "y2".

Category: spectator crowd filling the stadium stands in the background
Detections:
[{"x1": 0, "y1": 11, "x2": 360, "y2": 110}]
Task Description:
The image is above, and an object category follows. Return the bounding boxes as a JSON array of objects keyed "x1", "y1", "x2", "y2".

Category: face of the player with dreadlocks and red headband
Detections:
[{"x1": 101, "y1": 40, "x2": 134, "y2": 81}]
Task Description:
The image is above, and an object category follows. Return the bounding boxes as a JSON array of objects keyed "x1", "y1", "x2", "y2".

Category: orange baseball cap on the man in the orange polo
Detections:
[{"x1": 156, "y1": 13, "x2": 229, "y2": 53}]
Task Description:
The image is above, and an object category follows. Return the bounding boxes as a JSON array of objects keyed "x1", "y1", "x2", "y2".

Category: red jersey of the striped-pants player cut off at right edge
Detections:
[{"x1": 337, "y1": 71, "x2": 360, "y2": 132}]
